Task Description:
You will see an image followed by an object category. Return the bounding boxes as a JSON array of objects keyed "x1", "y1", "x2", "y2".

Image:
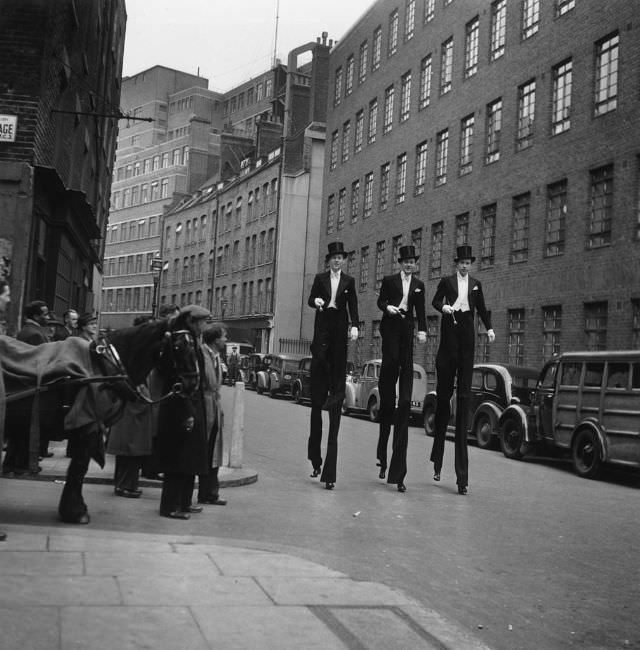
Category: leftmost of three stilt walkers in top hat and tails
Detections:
[{"x1": 307, "y1": 241, "x2": 359, "y2": 490}]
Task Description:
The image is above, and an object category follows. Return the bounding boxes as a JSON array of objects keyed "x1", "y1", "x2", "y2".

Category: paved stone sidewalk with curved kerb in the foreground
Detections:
[{"x1": 0, "y1": 525, "x2": 486, "y2": 650}]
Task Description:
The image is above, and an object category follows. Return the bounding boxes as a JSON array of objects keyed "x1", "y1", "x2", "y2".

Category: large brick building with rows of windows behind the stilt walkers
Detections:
[{"x1": 320, "y1": 0, "x2": 640, "y2": 376}]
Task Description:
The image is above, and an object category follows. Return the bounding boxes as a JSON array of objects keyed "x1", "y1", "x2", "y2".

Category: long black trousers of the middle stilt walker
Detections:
[{"x1": 377, "y1": 317, "x2": 413, "y2": 483}]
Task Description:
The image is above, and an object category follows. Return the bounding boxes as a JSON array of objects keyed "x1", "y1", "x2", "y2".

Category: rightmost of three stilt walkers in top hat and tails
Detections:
[{"x1": 431, "y1": 244, "x2": 495, "y2": 495}]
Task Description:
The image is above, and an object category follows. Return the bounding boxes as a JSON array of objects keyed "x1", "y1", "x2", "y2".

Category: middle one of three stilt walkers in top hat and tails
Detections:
[{"x1": 377, "y1": 246, "x2": 427, "y2": 492}]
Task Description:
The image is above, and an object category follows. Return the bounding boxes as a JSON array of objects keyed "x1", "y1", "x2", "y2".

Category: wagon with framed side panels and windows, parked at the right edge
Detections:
[{"x1": 499, "y1": 350, "x2": 640, "y2": 478}]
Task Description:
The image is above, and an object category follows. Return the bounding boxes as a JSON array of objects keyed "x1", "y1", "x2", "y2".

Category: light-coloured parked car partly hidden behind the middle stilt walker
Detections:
[{"x1": 342, "y1": 359, "x2": 427, "y2": 422}]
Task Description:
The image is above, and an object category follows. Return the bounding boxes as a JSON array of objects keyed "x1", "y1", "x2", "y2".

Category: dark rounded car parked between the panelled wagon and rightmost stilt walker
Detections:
[{"x1": 422, "y1": 363, "x2": 538, "y2": 449}]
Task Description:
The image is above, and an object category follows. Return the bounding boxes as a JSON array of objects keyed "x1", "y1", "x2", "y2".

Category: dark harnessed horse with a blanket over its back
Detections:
[{"x1": 0, "y1": 314, "x2": 200, "y2": 524}]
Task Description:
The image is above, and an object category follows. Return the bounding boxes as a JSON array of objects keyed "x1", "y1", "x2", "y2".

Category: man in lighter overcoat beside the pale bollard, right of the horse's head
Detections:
[{"x1": 198, "y1": 324, "x2": 227, "y2": 506}]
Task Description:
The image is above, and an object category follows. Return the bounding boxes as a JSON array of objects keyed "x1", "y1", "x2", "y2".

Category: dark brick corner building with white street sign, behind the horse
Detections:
[{"x1": 0, "y1": 0, "x2": 126, "y2": 332}]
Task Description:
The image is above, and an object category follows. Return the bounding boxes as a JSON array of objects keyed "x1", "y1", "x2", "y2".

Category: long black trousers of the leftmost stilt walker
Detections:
[{"x1": 307, "y1": 309, "x2": 347, "y2": 483}]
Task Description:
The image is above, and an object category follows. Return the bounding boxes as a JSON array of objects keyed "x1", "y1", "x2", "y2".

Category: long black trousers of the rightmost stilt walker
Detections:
[{"x1": 431, "y1": 311, "x2": 475, "y2": 486}]
